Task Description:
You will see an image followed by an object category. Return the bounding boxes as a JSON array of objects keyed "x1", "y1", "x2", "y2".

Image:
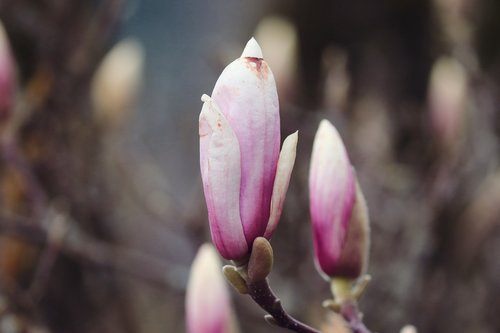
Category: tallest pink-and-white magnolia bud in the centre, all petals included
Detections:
[{"x1": 199, "y1": 38, "x2": 297, "y2": 261}]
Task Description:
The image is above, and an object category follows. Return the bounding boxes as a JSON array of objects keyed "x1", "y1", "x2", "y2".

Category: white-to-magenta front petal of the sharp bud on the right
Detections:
[{"x1": 309, "y1": 120, "x2": 354, "y2": 276}]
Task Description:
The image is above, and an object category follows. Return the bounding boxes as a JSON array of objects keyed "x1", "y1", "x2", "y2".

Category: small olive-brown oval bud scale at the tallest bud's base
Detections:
[{"x1": 248, "y1": 237, "x2": 273, "y2": 282}]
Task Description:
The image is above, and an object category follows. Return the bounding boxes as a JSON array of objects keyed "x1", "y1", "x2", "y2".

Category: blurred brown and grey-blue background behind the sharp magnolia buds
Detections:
[{"x1": 0, "y1": 0, "x2": 500, "y2": 333}]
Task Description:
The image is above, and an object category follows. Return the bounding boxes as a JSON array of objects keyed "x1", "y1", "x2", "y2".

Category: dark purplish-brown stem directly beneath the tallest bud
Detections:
[{"x1": 248, "y1": 279, "x2": 320, "y2": 333}]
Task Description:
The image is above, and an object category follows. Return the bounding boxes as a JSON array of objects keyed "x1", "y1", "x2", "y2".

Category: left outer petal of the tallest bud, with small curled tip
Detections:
[{"x1": 200, "y1": 95, "x2": 248, "y2": 259}]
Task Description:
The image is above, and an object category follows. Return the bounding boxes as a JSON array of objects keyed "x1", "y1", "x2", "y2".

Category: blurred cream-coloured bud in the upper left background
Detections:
[{"x1": 92, "y1": 39, "x2": 144, "y2": 129}]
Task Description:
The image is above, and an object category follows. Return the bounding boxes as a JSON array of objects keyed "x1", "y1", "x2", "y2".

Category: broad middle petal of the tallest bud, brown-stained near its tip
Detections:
[{"x1": 212, "y1": 41, "x2": 280, "y2": 243}]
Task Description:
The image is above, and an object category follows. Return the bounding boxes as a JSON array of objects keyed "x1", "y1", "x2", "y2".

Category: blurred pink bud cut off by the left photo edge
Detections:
[{"x1": 0, "y1": 22, "x2": 16, "y2": 131}]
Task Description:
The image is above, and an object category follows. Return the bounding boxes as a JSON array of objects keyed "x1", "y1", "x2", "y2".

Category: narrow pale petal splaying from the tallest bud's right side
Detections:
[{"x1": 264, "y1": 132, "x2": 298, "y2": 239}]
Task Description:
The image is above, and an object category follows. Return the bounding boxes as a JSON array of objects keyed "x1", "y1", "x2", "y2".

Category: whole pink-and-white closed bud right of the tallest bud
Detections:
[{"x1": 309, "y1": 120, "x2": 369, "y2": 279}]
